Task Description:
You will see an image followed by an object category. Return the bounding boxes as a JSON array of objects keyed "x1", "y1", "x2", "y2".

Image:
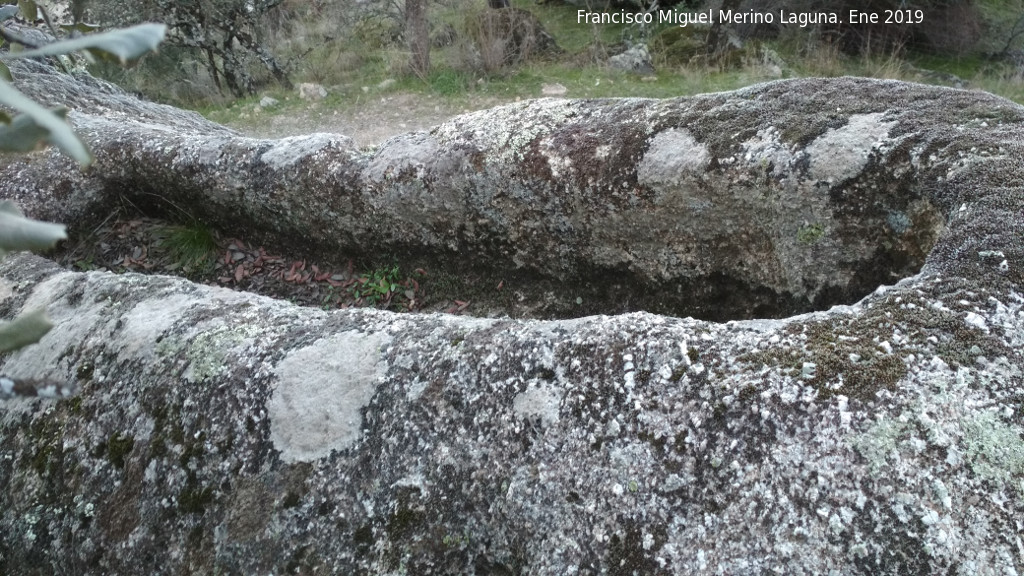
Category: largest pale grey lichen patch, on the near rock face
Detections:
[{"x1": 267, "y1": 331, "x2": 390, "y2": 462}]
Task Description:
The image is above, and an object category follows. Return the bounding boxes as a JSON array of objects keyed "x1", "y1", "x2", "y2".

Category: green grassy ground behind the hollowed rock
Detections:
[{"x1": 96, "y1": 0, "x2": 1024, "y2": 116}]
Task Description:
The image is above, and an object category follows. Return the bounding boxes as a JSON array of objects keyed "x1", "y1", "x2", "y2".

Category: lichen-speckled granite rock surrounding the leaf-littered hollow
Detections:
[{"x1": 0, "y1": 58, "x2": 1024, "y2": 575}]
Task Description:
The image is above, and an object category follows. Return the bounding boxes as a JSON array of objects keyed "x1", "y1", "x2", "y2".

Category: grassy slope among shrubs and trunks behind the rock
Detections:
[{"x1": 97, "y1": 0, "x2": 1024, "y2": 114}]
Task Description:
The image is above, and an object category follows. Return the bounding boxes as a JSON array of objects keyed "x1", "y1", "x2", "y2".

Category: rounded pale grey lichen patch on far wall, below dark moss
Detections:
[{"x1": 637, "y1": 128, "x2": 711, "y2": 186}]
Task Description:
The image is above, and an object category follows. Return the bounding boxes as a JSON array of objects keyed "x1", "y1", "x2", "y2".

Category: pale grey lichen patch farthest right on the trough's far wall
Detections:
[{"x1": 806, "y1": 113, "x2": 896, "y2": 183}]
